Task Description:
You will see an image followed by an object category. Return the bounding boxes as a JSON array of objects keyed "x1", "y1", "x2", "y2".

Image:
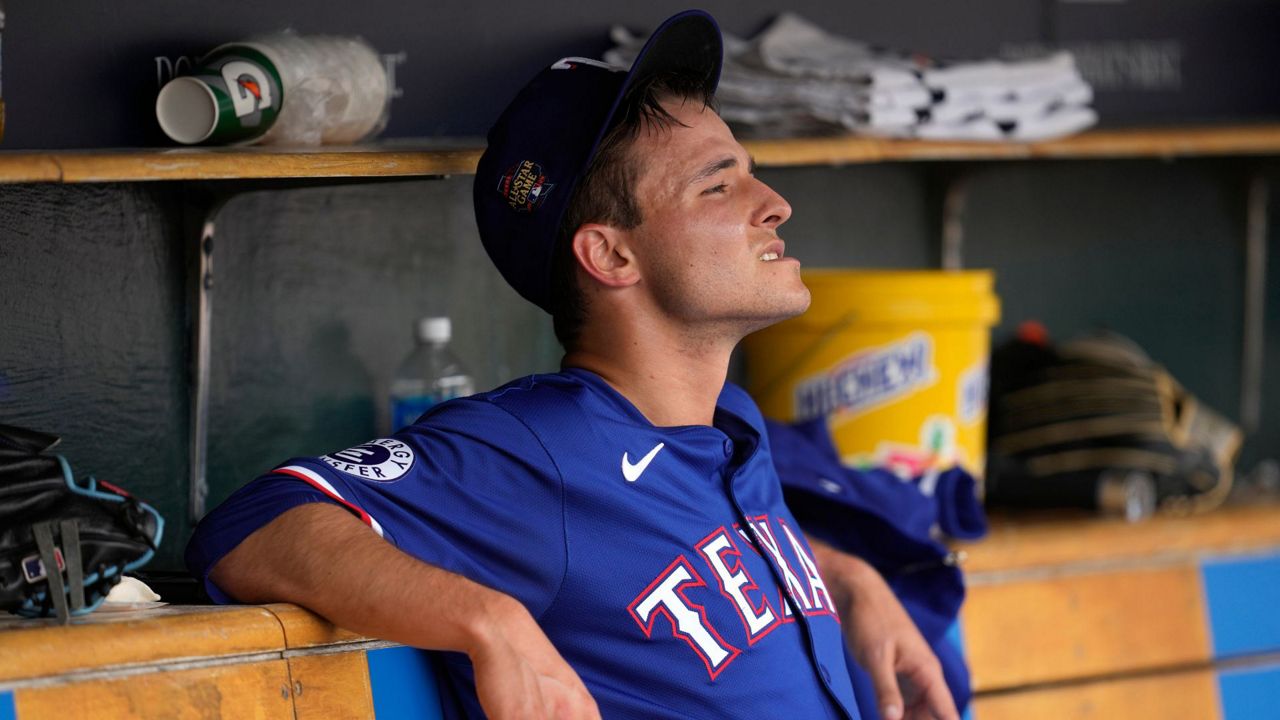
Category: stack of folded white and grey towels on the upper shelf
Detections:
[{"x1": 604, "y1": 13, "x2": 1098, "y2": 141}]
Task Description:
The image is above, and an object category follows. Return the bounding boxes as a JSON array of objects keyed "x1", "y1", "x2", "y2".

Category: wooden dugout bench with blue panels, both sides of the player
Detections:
[{"x1": 0, "y1": 506, "x2": 1280, "y2": 720}]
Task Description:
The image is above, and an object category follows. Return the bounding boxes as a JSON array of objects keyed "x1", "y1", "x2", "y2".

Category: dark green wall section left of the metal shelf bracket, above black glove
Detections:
[{"x1": 0, "y1": 184, "x2": 187, "y2": 566}]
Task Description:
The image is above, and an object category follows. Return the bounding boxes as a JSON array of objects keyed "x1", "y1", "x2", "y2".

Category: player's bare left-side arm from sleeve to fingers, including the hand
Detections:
[{"x1": 210, "y1": 502, "x2": 600, "y2": 720}]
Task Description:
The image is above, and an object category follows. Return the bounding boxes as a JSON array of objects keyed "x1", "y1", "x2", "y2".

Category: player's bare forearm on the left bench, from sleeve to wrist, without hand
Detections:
[{"x1": 210, "y1": 502, "x2": 527, "y2": 652}]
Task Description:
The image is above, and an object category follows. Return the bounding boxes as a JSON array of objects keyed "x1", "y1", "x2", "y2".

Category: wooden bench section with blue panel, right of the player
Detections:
[{"x1": 956, "y1": 506, "x2": 1280, "y2": 720}]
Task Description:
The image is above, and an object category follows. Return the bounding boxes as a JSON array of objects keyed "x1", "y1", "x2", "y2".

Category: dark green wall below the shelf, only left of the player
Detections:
[{"x1": 0, "y1": 178, "x2": 559, "y2": 568}]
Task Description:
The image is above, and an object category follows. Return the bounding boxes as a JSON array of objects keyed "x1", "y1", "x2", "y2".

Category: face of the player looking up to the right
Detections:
[{"x1": 631, "y1": 100, "x2": 809, "y2": 337}]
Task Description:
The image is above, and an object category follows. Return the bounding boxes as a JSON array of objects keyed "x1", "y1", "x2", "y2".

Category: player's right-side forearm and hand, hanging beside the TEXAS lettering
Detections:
[{"x1": 809, "y1": 537, "x2": 960, "y2": 720}]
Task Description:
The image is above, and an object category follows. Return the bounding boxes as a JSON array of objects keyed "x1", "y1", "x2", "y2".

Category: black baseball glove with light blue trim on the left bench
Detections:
[{"x1": 0, "y1": 425, "x2": 164, "y2": 623}]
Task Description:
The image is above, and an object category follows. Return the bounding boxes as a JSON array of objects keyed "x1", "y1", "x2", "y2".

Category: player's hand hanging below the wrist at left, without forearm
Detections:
[{"x1": 467, "y1": 596, "x2": 600, "y2": 720}]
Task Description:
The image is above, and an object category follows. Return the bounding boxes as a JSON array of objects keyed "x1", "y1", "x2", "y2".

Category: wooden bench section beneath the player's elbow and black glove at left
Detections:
[{"x1": 0, "y1": 605, "x2": 440, "y2": 720}]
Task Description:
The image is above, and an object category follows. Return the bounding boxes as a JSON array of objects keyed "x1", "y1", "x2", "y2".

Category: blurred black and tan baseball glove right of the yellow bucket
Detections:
[{"x1": 987, "y1": 333, "x2": 1242, "y2": 511}]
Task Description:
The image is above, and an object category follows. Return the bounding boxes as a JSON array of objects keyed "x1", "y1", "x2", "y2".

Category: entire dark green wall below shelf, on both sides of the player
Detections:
[{"x1": 0, "y1": 160, "x2": 1280, "y2": 568}]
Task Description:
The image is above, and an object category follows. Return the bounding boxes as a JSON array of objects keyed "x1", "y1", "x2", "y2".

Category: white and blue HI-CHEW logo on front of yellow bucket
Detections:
[{"x1": 795, "y1": 333, "x2": 938, "y2": 420}]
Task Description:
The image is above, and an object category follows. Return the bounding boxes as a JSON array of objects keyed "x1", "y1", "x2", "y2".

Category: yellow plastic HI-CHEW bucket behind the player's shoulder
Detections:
[{"x1": 745, "y1": 270, "x2": 1000, "y2": 478}]
